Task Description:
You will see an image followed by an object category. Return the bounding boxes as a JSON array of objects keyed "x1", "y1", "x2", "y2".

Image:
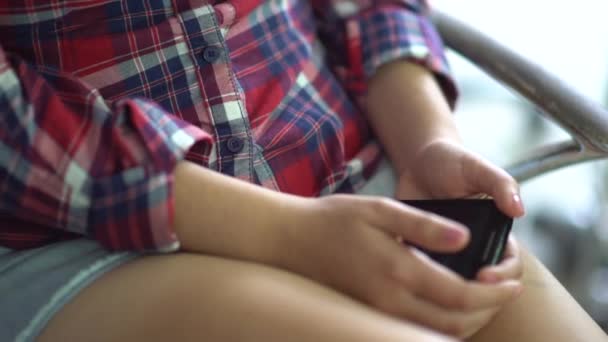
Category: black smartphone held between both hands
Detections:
[{"x1": 401, "y1": 199, "x2": 513, "y2": 279}]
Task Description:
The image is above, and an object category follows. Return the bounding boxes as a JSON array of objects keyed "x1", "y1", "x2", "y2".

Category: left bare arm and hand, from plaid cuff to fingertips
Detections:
[{"x1": 170, "y1": 158, "x2": 520, "y2": 335}]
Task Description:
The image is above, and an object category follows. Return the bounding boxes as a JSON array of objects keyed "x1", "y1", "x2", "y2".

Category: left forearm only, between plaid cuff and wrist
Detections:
[{"x1": 174, "y1": 162, "x2": 303, "y2": 263}]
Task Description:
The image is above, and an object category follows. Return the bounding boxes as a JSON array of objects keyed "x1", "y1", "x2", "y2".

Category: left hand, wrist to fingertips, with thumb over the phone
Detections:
[{"x1": 277, "y1": 195, "x2": 521, "y2": 337}]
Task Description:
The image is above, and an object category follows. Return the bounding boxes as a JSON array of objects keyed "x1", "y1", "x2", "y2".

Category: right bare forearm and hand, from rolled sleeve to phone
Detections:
[{"x1": 360, "y1": 60, "x2": 524, "y2": 337}]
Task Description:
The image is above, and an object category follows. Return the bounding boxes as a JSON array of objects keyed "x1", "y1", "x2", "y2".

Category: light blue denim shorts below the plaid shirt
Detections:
[{"x1": 0, "y1": 161, "x2": 395, "y2": 342}]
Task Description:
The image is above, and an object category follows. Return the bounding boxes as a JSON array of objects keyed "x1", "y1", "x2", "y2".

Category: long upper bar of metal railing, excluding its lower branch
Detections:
[{"x1": 433, "y1": 11, "x2": 608, "y2": 152}]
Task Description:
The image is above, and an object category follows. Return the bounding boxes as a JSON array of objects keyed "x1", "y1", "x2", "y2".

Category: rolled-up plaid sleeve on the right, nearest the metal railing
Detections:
[{"x1": 313, "y1": 0, "x2": 457, "y2": 107}]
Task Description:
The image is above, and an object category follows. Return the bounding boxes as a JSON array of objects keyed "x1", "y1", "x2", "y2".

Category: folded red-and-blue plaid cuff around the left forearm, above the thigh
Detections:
[{"x1": 88, "y1": 99, "x2": 213, "y2": 252}]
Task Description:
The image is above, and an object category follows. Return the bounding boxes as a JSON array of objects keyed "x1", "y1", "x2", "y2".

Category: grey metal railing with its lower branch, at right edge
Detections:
[{"x1": 432, "y1": 10, "x2": 608, "y2": 181}]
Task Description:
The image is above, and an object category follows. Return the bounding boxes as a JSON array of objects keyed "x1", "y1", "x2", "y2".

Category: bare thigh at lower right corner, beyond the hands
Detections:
[{"x1": 472, "y1": 244, "x2": 608, "y2": 342}]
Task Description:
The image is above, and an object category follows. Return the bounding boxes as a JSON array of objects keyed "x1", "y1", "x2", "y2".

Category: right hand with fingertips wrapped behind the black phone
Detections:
[{"x1": 395, "y1": 140, "x2": 524, "y2": 332}]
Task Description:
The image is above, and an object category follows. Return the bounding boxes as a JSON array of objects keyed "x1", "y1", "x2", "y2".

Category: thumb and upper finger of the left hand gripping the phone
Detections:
[{"x1": 360, "y1": 200, "x2": 522, "y2": 310}]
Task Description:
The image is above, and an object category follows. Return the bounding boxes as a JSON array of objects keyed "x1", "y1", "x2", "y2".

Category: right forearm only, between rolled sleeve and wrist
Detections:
[{"x1": 368, "y1": 61, "x2": 460, "y2": 171}]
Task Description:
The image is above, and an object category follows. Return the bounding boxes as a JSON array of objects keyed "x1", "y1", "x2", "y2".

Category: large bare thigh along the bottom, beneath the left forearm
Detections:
[{"x1": 39, "y1": 254, "x2": 446, "y2": 341}]
